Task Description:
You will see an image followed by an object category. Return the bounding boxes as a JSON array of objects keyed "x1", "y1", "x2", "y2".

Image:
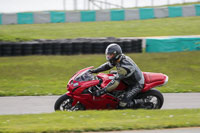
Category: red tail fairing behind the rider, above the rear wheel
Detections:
[{"x1": 142, "y1": 72, "x2": 168, "y2": 92}]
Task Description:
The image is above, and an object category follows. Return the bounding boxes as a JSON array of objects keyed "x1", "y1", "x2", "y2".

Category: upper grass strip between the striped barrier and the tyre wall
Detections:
[{"x1": 0, "y1": 16, "x2": 200, "y2": 41}]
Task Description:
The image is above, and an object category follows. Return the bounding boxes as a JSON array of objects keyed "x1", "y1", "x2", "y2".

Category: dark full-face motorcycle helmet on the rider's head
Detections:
[{"x1": 105, "y1": 43, "x2": 122, "y2": 65}]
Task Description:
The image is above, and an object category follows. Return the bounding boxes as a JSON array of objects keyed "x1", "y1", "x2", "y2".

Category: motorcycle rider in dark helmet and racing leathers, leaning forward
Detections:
[{"x1": 91, "y1": 43, "x2": 144, "y2": 108}]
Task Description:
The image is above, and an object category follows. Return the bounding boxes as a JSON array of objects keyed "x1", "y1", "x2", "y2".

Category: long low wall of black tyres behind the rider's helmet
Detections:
[{"x1": 0, "y1": 38, "x2": 142, "y2": 56}]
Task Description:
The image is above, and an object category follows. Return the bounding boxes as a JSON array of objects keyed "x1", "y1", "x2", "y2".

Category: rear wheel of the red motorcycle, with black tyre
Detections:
[{"x1": 136, "y1": 89, "x2": 164, "y2": 109}]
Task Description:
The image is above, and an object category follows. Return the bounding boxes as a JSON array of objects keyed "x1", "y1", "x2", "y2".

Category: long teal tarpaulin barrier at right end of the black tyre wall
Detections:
[{"x1": 146, "y1": 38, "x2": 200, "y2": 53}]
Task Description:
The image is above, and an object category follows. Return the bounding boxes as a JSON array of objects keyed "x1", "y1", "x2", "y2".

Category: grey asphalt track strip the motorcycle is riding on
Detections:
[{"x1": 0, "y1": 93, "x2": 200, "y2": 115}]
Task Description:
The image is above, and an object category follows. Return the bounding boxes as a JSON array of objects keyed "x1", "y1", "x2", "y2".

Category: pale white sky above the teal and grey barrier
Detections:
[{"x1": 0, "y1": 0, "x2": 200, "y2": 13}]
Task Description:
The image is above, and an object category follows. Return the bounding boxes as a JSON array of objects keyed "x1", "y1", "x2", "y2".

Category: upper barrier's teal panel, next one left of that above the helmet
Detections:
[{"x1": 81, "y1": 11, "x2": 96, "y2": 22}]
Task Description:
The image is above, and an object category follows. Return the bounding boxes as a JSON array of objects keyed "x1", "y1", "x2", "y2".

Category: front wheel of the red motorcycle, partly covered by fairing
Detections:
[{"x1": 54, "y1": 94, "x2": 73, "y2": 111}]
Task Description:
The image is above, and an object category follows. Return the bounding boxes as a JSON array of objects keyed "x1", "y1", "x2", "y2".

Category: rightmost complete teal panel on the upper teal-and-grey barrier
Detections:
[{"x1": 168, "y1": 6, "x2": 183, "y2": 18}]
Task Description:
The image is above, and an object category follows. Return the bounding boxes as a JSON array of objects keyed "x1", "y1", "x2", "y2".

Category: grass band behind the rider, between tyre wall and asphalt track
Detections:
[{"x1": 0, "y1": 51, "x2": 200, "y2": 96}]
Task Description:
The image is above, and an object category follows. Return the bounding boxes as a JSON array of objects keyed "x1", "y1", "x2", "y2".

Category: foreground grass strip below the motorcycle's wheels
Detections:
[{"x1": 0, "y1": 109, "x2": 200, "y2": 133}]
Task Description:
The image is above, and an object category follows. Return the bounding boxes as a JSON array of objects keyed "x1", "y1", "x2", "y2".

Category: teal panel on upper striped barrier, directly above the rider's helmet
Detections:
[{"x1": 110, "y1": 10, "x2": 125, "y2": 21}]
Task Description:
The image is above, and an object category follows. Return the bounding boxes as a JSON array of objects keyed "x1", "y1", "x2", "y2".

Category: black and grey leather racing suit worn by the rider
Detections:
[{"x1": 93, "y1": 55, "x2": 144, "y2": 107}]
